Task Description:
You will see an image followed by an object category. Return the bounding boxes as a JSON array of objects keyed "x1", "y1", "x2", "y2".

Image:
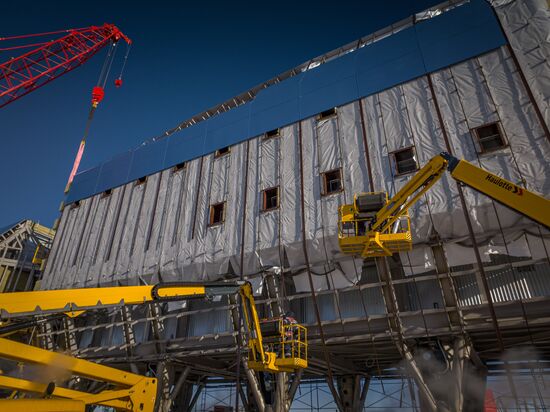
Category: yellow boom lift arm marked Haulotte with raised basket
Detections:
[{"x1": 338, "y1": 152, "x2": 550, "y2": 258}]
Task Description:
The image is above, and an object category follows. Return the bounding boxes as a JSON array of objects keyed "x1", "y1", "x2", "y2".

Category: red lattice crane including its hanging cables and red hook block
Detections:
[{"x1": 0, "y1": 23, "x2": 132, "y2": 193}]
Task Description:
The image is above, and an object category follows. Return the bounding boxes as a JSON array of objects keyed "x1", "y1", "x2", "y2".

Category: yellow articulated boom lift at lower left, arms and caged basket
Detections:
[{"x1": 0, "y1": 281, "x2": 307, "y2": 412}]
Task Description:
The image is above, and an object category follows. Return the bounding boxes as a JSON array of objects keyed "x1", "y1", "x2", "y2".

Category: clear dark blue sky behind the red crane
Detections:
[{"x1": 0, "y1": 0, "x2": 439, "y2": 226}]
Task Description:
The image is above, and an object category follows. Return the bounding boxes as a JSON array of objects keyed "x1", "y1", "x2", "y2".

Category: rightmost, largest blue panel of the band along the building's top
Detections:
[{"x1": 415, "y1": 0, "x2": 506, "y2": 72}]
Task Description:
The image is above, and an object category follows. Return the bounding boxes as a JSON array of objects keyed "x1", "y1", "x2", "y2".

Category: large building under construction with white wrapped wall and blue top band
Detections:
[{"x1": 38, "y1": 0, "x2": 550, "y2": 411}]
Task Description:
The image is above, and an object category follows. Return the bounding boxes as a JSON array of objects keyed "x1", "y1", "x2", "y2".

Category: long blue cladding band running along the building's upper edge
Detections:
[{"x1": 67, "y1": 0, "x2": 505, "y2": 203}]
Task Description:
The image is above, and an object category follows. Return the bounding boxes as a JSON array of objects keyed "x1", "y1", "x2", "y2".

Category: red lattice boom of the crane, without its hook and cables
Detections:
[{"x1": 0, "y1": 23, "x2": 131, "y2": 107}]
